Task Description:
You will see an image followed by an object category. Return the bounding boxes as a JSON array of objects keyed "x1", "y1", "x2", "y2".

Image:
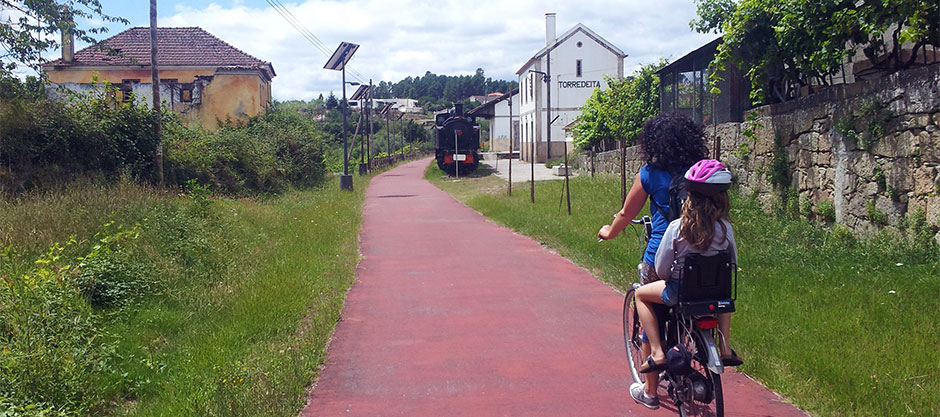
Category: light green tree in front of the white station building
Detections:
[{"x1": 573, "y1": 60, "x2": 667, "y2": 149}]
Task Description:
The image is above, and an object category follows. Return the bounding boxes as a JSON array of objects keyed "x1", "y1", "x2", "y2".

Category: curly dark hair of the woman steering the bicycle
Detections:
[{"x1": 640, "y1": 113, "x2": 708, "y2": 170}]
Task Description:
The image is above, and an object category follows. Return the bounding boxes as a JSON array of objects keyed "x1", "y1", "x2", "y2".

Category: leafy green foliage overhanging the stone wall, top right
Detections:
[{"x1": 691, "y1": 0, "x2": 940, "y2": 103}]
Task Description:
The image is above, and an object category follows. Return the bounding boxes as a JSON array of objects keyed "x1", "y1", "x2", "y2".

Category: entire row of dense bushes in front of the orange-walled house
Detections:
[{"x1": 0, "y1": 80, "x2": 328, "y2": 194}]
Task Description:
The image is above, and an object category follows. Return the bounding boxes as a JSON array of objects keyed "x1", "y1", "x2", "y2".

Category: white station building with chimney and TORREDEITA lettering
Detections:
[{"x1": 513, "y1": 13, "x2": 627, "y2": 162}]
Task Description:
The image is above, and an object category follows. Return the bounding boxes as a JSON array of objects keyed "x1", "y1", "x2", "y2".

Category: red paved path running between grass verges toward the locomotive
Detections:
[{"x1": 303, "y1": 160, "x2": 803, "y2": 416}]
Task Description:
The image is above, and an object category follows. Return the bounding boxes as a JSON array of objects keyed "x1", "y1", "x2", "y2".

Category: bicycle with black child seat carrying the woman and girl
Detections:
[{"x1": 623, "y1": 216, "x2": 737, "y2": 417}]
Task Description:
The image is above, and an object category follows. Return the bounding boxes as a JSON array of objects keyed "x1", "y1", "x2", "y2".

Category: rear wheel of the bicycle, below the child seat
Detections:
[{"x1": 679, "y1": 332, "x2": 725, "y2": 417}]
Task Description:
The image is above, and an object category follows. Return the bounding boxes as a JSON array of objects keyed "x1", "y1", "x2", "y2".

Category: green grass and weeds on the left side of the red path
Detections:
[{"x1": 0, "y1": 177, "x2": 369, "y2": 416}]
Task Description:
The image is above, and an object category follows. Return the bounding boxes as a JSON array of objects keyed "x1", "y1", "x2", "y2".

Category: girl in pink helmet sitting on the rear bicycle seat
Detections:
[{"x1": 630, "y1": 159, "x2": 742, "y2": 408}]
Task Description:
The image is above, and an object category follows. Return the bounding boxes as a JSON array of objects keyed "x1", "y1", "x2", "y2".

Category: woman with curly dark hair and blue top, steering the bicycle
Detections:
[{"x1": 597, "y1": 113, "x2": 707, "y2": 407}]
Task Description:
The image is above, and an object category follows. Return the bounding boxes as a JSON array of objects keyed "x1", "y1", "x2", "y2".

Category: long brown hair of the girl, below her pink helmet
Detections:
[{"x1": 679, "y1": 191, "x2": 731, "y2": 251}]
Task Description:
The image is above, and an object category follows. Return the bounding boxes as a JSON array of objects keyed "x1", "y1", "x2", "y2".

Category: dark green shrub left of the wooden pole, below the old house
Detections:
[{"x1": 0, "y1": 80, "x2": 156, "y2": 190}]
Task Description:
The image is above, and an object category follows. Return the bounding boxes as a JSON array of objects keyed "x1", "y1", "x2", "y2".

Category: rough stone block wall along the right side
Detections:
[{"x1": 576, "y1": 64, "x2": 940, "y2": 238}]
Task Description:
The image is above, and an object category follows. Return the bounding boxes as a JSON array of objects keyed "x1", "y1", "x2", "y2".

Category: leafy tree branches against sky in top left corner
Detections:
[{"x1": 0, "y1": 0, "x2": 130, "y2": 76}]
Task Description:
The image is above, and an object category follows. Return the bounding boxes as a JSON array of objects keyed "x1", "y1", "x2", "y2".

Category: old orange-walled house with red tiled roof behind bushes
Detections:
[{"x1": 44, "y1": 27, "x2": 276, "y2": 129}]
